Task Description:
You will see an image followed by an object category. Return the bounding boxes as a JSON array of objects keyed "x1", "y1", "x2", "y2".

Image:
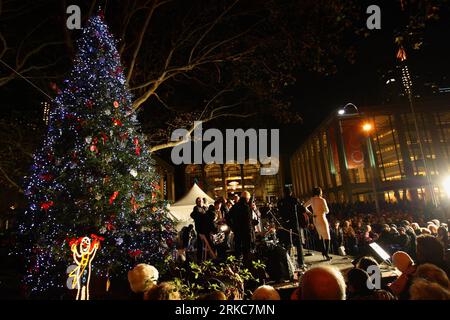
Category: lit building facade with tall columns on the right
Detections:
[{"x1": 290, "y1": 98, "x2": 450, "y2": 203}]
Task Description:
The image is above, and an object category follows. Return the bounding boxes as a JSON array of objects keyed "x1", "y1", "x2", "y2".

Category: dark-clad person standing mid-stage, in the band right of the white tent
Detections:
[{"x1": 229, "y1": 191, "x2": 255, "y2": 266}]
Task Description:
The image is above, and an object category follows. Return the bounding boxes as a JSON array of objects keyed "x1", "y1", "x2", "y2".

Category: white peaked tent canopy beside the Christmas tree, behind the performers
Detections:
[{"x1": 169, "y1": 183, "x2": 214, "y2": 230}]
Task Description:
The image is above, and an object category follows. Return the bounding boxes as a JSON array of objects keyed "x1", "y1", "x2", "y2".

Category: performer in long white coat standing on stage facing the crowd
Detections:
[{"x1": 304, "y1": 187, "x2": 332, "y2": 260}]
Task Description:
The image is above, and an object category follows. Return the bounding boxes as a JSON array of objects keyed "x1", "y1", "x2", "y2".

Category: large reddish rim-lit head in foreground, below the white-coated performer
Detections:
[{"x1": 300, "y1": 266, "x2": 346, "y2": 300}]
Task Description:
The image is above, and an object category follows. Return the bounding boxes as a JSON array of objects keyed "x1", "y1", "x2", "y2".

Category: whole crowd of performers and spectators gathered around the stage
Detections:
[{"x1": 149, "y1": 188, "x2": 450, "y2": 300}]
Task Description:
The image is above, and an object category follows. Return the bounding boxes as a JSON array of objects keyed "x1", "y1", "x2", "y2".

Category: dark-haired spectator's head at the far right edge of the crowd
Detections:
[{"x1": 416, "y1": 235, "x2": 450, "y2": 276}]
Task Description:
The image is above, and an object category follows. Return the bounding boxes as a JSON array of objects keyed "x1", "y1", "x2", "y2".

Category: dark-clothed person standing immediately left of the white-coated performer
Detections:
[{"x1": 277, "y1": 187, "x2": 309, "y2": 268}]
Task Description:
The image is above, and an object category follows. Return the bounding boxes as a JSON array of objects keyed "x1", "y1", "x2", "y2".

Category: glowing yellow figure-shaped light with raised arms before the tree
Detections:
[{"x1": 67, "y1": 234, "x2": 104, "y2": 300}]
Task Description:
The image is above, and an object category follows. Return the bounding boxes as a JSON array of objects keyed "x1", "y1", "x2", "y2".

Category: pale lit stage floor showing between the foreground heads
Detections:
[{"x1": 267, "y1": 251, "x2": 399, "y2": 300}]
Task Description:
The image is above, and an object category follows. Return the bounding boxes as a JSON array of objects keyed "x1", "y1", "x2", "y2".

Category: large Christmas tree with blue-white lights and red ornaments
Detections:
[{"x1": 21, "y1": 15, "x2": 174, "y2": 292}]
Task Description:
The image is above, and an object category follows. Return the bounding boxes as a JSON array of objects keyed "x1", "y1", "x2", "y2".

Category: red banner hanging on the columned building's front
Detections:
[{"x1": 341, "y1": 120, "x2": 364, "y2": 169}]
